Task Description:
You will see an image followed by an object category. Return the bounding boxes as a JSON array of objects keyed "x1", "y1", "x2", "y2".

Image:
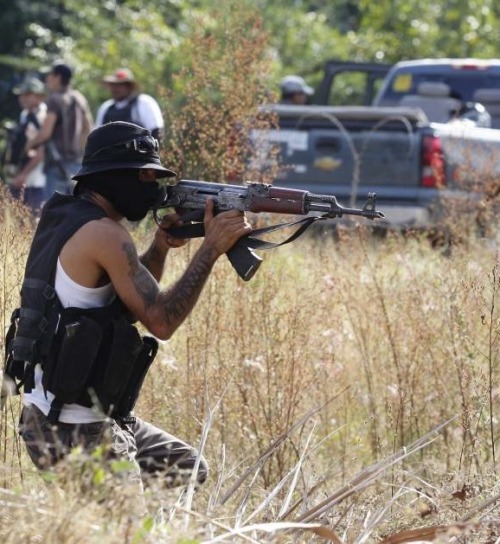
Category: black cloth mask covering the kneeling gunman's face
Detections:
[{"x1": 80, "y1": 170, "x2": 161, "y2": 221}]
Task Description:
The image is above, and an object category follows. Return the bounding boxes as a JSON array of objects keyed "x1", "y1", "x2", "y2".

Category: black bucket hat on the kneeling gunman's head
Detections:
[{"x1": 73, "y1": 121, "x2": 177, "y2": 181}]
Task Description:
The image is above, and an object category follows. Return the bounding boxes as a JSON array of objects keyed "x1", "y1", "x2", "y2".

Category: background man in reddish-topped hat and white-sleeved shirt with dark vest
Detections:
[{"x1": 95, "y1": 68, "x2": 164, "y2": 140}]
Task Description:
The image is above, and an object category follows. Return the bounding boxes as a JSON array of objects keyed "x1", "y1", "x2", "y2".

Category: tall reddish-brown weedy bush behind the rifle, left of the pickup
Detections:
[{"x1": 163, "y1": 4, "x2": 278, "y2": 181}]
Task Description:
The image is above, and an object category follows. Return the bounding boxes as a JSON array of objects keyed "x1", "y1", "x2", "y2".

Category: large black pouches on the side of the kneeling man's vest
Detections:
[{"x1": 43, "y1": 315, "x2": 158, "y2": 422}]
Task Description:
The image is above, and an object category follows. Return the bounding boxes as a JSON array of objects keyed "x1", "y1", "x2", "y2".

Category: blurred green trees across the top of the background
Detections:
[{"x1": 0, "y1": 0, "x2": 500, "y2": 121}]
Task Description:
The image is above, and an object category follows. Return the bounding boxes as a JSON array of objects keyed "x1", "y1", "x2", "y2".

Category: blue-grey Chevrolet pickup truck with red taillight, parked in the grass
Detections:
[{"x1": 251, "y1": 59, "x2": 500, "y2": 228}]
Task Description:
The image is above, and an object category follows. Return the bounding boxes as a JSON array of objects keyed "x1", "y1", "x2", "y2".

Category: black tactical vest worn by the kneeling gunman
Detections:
[{"x1": 4, "y1": 193, "x2": 158, "y2": 423}]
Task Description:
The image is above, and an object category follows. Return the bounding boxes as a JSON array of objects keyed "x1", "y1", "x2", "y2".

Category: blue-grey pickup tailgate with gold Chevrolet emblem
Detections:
[{"x1": 252, "y1": 106, "x2": 428, "y2": 209}]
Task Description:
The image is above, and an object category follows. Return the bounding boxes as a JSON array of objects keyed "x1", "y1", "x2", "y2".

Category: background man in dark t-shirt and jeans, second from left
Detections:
[{"x1": 29, "y1": 62, "x2": 93, "y2": 199}]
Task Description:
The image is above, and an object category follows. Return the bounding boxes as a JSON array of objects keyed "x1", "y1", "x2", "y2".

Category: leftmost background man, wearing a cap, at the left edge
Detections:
[{"x1": 7, "y1": 77, "x2": 47, "y2": 215}]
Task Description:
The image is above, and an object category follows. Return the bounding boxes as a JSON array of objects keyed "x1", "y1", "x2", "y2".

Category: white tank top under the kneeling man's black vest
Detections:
[{"x1": 24, "y1": 259, "x2": 116, "y2": 423}]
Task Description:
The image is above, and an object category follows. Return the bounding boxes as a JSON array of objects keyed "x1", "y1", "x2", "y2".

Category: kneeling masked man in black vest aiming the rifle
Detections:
[{"x1": 6, "y1": 121, "x2": 251, "y2": 492}]
